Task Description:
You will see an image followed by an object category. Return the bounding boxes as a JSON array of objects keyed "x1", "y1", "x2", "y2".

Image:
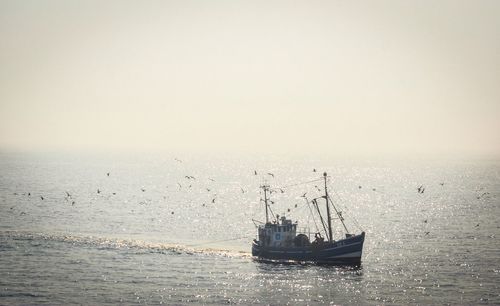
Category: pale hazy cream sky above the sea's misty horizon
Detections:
[{"x1": 0, "y1": 0, "x2": 500, "y2": 157}]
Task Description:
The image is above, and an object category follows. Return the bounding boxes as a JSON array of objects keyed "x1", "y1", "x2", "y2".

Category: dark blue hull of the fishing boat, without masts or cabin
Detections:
[{"x1": 252, "y1": 232, "x2": 365, "y2": 265}]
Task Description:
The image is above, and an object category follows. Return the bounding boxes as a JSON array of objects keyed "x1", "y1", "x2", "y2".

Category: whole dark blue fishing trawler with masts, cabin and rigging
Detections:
[{"x1": 252, "y1": 172, "x2": 365, "y2": 265}]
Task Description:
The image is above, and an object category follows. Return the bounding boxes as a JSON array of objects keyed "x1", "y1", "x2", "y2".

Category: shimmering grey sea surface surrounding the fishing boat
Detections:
[{"x1": 0, "y1": 154, "x2": 500, "y2": 304}]
